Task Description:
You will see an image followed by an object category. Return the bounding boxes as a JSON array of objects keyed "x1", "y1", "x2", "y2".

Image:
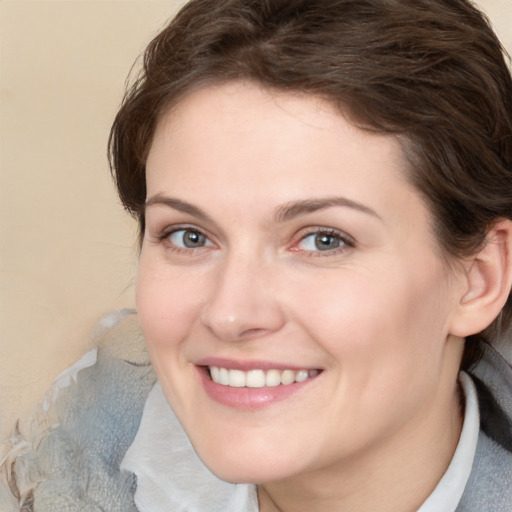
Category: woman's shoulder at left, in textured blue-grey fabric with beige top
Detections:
[{"x1": 3, "y1": 314, "x2": 156, "y2": 512}]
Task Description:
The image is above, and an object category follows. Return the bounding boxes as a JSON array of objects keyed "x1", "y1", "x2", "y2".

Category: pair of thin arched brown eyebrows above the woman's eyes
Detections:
[{"x1": 145, "y1": 194, "x2": 382, "y2": 223}]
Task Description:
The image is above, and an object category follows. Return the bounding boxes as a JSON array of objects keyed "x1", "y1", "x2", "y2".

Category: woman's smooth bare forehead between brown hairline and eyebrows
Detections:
[{"x1": 147, "y1": 82, "x2": 406, "y2": 195}]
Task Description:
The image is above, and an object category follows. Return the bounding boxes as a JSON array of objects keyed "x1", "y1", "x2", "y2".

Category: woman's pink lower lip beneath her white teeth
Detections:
[{"x1": 197, "y1": 366, "x2": 318, "y2": 411}]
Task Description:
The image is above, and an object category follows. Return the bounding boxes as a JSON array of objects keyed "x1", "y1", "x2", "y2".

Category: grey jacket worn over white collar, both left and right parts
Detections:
[{"x1": 0, "y1": 315, "x2": 512, "y2": 512}]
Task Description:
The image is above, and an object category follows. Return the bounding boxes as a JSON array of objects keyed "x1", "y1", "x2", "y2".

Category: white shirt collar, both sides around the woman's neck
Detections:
[{"x1": 121, "y1": 372, "x2": 480, "y2": 512}]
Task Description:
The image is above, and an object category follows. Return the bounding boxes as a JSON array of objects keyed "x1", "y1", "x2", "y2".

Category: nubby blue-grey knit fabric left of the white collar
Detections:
[{"x1": 27, "y1": 351, "x2": 155, "y2": 512}]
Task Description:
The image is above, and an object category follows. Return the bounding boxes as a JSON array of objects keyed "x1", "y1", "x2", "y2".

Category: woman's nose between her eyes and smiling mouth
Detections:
[{"x1": 201, "y1": 256, "x2": 285, "y2": 341}]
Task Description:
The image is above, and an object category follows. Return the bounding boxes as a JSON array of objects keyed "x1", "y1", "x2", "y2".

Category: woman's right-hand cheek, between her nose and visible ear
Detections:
[{"x1": 289, "y1": 262, "x2": 447, "y2": 378}]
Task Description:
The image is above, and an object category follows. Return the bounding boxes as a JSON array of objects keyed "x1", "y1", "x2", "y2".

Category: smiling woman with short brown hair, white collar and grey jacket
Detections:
[{"x1": 1, "y1": 0, "x2": 512, "y2": 512}]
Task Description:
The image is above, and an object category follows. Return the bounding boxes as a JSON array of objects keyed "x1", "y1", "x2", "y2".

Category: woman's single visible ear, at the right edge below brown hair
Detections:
[{"x1": 450, "y1": 219, "x2": 512, "y2": 338}]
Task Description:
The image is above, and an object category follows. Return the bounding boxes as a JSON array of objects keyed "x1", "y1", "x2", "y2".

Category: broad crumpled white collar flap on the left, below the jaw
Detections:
[{"x1": 121, "y1": 383, "x2": 258, "y2": 512}]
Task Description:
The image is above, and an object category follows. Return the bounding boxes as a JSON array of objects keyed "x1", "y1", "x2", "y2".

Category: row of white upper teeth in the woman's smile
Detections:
[{"x1": 208, "y1": 366, "x2": 318, "y2": 388}]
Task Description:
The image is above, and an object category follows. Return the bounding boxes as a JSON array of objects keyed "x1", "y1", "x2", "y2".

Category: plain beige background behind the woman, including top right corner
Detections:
[{"x1": 0, "y1": 0, "x2": 512, "y2": 436}]
